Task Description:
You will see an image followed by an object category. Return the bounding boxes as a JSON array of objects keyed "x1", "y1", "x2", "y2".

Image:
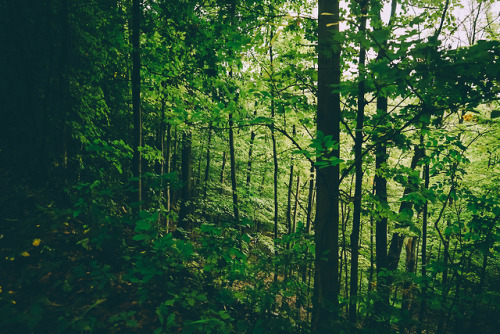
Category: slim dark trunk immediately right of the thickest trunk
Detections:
[{"x1": 349, "y1": 0, "x2": 368, "y2": 323}]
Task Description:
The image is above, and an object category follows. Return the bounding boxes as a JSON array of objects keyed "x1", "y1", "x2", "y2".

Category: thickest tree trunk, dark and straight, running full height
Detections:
[{"x1": 312, "y1": 0, "x2": 341, "y2": 333}]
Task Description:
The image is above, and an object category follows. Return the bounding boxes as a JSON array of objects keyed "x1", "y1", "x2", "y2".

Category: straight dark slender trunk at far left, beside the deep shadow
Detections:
[{"x1": 131, "y1": 0, "x2": 142, "y2": 211}]
